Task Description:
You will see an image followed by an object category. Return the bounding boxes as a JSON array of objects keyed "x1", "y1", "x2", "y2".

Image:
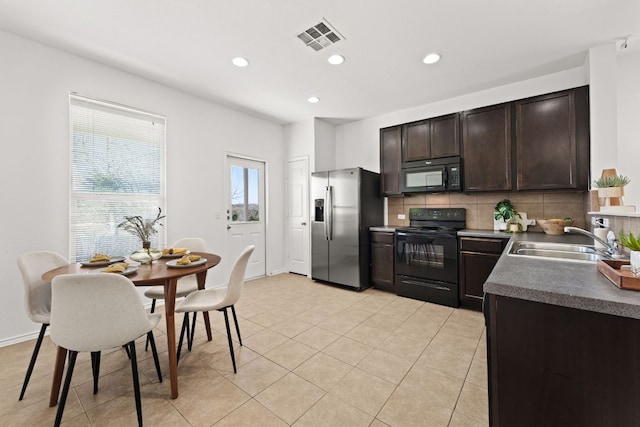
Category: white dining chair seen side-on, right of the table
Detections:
[{"x1": 175, "y1": 245, "x2": 255, "y2": 373}]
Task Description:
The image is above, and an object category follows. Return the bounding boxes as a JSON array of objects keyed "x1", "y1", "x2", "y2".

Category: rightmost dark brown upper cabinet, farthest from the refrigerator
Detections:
[{"x1": 514, "y1": 87, "x2": 589, "y2": 190}]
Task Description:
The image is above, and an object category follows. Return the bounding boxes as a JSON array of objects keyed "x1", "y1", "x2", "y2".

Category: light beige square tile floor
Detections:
[{"x1": 0, "y1": 274, "x2": 488, "y2": 427}]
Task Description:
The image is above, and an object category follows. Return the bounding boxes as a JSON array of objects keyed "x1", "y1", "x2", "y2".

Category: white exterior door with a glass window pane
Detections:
[{"x1": 226, "y1": 156, "x2": 266, "y2": 279}]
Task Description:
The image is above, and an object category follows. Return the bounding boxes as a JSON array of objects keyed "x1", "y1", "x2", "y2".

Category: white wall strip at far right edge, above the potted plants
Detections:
[{"x1": 616, "y1": 52, "x2": 640, "y2": 210}]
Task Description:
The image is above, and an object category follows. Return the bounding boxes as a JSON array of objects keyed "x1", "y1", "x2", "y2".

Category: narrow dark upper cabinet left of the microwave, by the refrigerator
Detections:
[{"x1": 380, "y1": 125, "x2": 402, "y2": 196}]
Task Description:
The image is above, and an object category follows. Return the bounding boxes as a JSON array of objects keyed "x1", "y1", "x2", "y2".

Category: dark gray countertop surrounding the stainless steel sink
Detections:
[{"x1": 484, "y1": 233, "x2": 640, "y2": 319}]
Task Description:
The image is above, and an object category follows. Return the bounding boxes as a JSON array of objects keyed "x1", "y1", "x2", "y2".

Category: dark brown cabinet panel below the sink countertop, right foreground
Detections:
[{"x1": 484, "y1": 295, "x2": 640, "y2": 427}]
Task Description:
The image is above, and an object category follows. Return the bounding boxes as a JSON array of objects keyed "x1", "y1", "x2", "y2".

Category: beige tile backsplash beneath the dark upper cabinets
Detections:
[{"x1": 387, "y1": 192, "x2": 588, "y2": 232}]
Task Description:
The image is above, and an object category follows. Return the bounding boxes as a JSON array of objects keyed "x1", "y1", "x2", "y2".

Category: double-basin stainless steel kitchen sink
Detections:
[{"x1": 507, "y1": 241, "x2": 611, "y2": 263}]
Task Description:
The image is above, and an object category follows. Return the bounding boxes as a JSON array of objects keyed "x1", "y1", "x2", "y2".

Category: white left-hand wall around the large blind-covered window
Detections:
[{"x1": 0, "y1": 32, "x2": 286, "y2": 345}]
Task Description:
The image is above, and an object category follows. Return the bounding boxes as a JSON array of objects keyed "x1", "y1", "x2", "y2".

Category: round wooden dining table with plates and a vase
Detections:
[{"x1": 42, "y1": 252, "x2": 220, "y2": 406}]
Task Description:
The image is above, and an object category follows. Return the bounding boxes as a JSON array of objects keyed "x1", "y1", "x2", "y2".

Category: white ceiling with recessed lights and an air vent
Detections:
[{"x1": 0, "y1": 0, "x2": 640, "y2": 123}]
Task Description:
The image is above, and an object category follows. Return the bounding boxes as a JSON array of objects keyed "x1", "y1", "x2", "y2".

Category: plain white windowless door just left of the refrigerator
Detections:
[{"x1": 287, "y1": 158, "x2": 309, "y2": 276}]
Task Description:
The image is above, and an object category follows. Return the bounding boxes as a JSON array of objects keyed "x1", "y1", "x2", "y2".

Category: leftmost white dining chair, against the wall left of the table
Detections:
[{"x1": 18, "y1": 251, "x2": 69, "y2": 400}]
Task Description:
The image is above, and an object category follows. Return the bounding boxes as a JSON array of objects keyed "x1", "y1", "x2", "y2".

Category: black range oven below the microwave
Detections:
[{"x1": 395, "y1": 208, "x2": 466, "y2": 307}]
